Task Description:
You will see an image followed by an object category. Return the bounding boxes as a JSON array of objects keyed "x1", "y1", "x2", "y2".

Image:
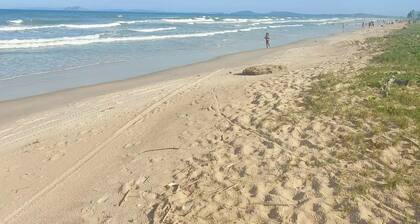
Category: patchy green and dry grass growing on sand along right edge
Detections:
[{"x1": 305, "y1": 24, "x2": 420, "y2": 223}]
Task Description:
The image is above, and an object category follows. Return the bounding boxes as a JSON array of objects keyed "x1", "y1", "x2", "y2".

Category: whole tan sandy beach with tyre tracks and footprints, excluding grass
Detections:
[{"x1": 0, "y1": 24, "x2": 418, "y2": 224}]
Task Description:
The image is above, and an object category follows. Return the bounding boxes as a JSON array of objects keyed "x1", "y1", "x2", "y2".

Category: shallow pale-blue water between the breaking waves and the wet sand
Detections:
[{"x1": 0, "y1": 17, "x2": 360, "y2": 101}]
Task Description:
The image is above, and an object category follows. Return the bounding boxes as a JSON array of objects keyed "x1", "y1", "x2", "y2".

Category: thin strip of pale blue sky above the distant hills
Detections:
[{"x1": 0, "y1": 0, "x2": 420, "y2": 16}]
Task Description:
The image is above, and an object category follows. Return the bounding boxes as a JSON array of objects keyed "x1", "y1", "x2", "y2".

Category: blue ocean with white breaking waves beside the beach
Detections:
[{"x1": 0, "y1": 10, "x2": 386, "y2": 101}]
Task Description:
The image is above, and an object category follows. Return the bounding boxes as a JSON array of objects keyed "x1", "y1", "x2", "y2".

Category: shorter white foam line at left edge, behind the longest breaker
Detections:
[{"x1": 0, "y1": 20, "x2": 143, "y2": 32}]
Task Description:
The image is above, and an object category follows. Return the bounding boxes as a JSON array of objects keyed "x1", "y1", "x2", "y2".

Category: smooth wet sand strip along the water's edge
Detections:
[{"x1": 0, "y1": 29, "x2": 354, "y2": 125}]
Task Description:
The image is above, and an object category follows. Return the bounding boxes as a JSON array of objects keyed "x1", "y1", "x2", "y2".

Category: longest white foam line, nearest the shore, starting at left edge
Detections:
[{"x1": 0, "y1": 29, "x2": 246, "y2": 49}]
